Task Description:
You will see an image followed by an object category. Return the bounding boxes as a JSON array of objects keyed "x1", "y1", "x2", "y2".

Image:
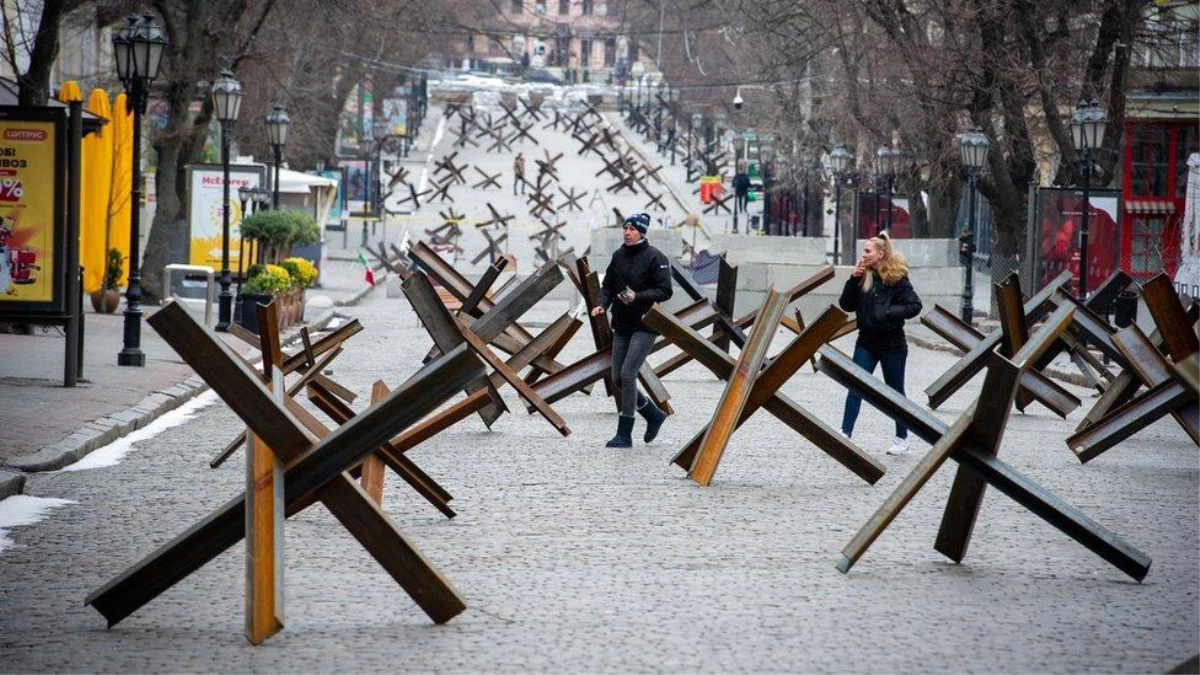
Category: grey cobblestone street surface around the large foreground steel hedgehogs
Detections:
[{"x1": 0, "y1": 279, "x2": 1200, "y2": 673}]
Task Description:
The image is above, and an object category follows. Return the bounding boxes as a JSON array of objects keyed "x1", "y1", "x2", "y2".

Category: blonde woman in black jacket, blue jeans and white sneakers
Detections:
[{"x1": 838, "y1": 232, "x2": 920, "y2": 455}]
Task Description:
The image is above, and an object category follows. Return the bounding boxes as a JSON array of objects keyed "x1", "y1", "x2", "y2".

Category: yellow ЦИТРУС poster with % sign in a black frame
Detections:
[{"x1": 0, "y1": 119, "x2": 58, "y2": 304}]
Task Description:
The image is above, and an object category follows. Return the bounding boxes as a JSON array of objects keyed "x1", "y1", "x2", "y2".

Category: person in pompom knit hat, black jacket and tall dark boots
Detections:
[{"x1": 592, "y1": 214, "x2": 672, "y2": 448}]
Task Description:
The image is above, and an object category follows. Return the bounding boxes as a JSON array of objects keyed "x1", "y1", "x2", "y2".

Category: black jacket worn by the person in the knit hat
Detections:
[{"x1": 599, "y1": 238, "x2": 673, "y2": 333}]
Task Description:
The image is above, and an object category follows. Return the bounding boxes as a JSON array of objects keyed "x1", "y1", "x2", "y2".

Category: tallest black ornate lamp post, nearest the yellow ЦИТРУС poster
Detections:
[{"x1": 113, "y1": 14, "x2": 167, "y2": 366}]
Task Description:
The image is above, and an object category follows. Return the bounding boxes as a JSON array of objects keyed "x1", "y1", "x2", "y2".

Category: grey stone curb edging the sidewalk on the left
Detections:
[{"x1": 0, "y1": 310, "x2": 336, "y2": 473}]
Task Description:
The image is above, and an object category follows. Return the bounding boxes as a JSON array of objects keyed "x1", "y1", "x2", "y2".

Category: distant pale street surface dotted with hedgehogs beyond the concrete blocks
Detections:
[{"x1": 326, "y1": 97, "x2": 705, "y2": 275}]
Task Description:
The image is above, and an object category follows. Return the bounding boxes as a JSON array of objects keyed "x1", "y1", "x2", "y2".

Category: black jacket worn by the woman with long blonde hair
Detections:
[{"x1": 838, "y1": 270, "x2": 920, "y2": 354}]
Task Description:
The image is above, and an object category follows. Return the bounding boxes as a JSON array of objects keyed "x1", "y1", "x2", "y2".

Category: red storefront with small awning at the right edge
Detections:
[{"x1": 1121, "y1": 119, "x2": 1200, "y2": 280}]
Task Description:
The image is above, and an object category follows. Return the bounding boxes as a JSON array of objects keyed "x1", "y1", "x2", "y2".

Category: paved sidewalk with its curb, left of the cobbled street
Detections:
[{"x1": 0, "y1": 257, "x2": 379, "y2": 500}]
